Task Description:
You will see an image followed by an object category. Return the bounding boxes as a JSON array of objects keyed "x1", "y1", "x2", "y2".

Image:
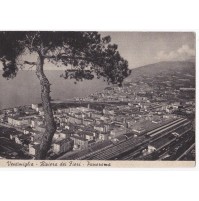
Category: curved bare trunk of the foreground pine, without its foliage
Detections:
[{"x1": 36, "y1": 55, "x2": 56, "y2": 160}]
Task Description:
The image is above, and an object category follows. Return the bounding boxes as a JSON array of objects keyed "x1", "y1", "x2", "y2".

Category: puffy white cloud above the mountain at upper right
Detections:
[{"x1": 156, "y1": 45, "x2": 195, "y2": 61}]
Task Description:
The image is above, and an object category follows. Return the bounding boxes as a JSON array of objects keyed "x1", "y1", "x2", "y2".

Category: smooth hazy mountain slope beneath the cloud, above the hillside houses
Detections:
[{"x1": 127, "y1": 61, "x2": 195, "y2": 80}]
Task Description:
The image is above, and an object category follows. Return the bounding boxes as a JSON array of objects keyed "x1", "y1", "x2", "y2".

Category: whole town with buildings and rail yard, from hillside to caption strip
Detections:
[{"x1": 0, "y1": 65, "x2": 195, "y2": 160}]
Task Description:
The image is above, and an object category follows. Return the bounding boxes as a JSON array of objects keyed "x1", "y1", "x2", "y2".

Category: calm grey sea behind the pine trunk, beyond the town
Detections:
[{"x1": 0, "y1": 70, "x2": 108, "y2": 110}]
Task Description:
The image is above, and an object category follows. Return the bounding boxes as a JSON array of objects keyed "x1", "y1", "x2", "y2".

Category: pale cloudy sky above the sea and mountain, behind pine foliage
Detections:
[{"x1": 0, "y1": 32, "x2": 195, "y2": 70}]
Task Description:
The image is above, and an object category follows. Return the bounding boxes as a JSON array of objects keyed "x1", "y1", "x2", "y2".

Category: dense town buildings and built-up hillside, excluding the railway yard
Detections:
[{"x1": 0, "y1": 67, "x2": 195, "y2": 159}]
